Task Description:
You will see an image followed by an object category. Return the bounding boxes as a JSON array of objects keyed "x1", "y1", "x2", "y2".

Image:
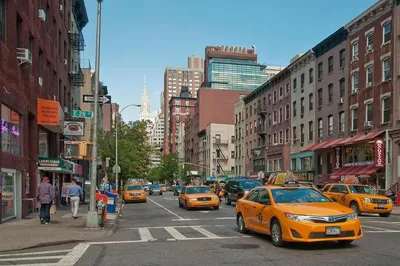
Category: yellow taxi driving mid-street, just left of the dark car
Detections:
[{"x1": 178, "y1": 185, "x2": 220, "y2": 210}]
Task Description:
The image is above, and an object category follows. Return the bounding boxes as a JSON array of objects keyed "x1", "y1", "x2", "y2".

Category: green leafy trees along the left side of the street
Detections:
[{"x1": 98, "y1": 121, "x2": 151, "y2": 181}]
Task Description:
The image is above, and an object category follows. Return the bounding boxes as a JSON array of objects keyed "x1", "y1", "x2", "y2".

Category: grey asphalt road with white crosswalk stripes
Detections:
[{"x1": 0, "y1": 193, "x2": 400, "y2": 266}]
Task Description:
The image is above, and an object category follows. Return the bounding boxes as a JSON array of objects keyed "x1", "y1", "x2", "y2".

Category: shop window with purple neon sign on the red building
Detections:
[{"x1": 0, "y1": 105, "x2": 21, "y2": 155}]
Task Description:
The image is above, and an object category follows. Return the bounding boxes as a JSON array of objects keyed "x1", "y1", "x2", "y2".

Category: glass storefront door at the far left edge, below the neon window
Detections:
[{"x1": 0, "y1": 168, "x2": 17, "y2": 221}]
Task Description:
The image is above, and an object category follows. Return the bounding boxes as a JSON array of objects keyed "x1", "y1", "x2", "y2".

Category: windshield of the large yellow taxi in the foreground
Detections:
[{"x1": 271, "y1": 188, "x2": 330, "y2": 203}]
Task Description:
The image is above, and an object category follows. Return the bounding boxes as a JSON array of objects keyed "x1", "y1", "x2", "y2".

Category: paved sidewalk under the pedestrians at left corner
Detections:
[{"x1": 0, "y1": 202, "x2": 121, "y2": 252}]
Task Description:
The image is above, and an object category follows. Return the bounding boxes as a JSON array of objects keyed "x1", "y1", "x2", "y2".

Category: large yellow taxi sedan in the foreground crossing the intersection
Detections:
[{"x1": 236, "y1": 181, "x2": 364, "y2": 247}]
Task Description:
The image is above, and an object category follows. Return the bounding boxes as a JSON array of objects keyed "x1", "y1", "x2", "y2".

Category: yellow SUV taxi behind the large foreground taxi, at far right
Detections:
[{"x1": 323, "y1": 183, "x2": 393, "y2": 217}]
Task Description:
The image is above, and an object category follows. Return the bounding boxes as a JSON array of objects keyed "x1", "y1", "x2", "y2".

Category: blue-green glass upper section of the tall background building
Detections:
[{"x1": 208, "y1": 58, "x2": 268, "y2": 90}]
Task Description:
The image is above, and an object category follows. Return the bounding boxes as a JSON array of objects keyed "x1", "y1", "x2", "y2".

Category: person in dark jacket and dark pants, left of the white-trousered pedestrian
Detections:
[{"x1": 36, "y1": 176, "x2": 56, "y2": 224}]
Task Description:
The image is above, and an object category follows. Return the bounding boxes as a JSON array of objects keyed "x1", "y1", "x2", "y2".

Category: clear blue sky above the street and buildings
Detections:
[{"x1": 82, "y1": 0, "x2": 377, "y2": 121}]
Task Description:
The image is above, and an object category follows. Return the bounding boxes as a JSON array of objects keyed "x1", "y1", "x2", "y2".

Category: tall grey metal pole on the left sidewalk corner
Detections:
[{"x1": 86, "y1": 0, "x2": 103, "y2": 228}]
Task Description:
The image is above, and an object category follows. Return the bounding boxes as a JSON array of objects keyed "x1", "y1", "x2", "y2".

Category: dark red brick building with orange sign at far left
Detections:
[{"x1": 0, "y1": 0, "x2": 87, "y2": 223}]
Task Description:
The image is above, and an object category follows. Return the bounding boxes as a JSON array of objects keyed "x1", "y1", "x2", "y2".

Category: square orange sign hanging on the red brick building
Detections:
[{"x1": 37, "y1": 99, "x2": 60, "y2": 126}]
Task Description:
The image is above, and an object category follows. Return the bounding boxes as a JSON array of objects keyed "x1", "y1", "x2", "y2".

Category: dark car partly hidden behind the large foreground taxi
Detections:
[{"x1": 224, "y1": 179, "x2": 262, "y2": 205}]
